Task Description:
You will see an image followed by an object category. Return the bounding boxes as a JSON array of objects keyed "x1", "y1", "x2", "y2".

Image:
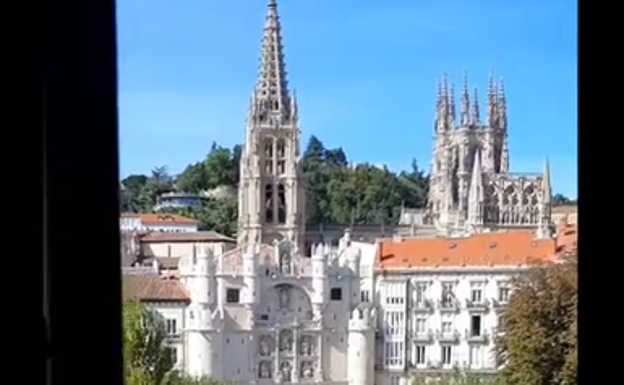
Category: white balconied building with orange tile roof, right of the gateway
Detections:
[{"x1": 375, "y1": 231, "x2": 556, "y2": 385}]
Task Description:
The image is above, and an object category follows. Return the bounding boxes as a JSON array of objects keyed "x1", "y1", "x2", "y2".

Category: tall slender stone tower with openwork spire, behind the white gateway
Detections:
[{"x1": 238, "y1": 0, "x2": 305, "y2": 250}]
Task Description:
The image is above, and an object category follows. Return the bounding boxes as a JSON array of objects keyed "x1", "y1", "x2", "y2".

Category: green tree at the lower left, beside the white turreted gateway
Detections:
[{"x1": 123, "y1": 302, "x2": 173, "y2": 385}]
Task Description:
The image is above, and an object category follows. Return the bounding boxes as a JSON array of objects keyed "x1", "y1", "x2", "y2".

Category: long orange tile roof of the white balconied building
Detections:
[{"x1": 375, "y1": 231, "x2": 555, "y2": 269}]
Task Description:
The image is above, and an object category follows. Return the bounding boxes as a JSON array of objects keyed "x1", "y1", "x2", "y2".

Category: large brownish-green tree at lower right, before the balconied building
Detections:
[{"x1": 497, "y1": 255, "x2": 578, "y2": 385}]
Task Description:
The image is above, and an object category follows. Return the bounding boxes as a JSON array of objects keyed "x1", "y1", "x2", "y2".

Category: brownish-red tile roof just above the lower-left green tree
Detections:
[{"x1": 122, "y1": 275, "x2": 190, "y2": 302}]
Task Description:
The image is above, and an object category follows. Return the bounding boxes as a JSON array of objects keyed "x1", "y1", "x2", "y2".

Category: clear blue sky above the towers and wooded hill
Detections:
[{"x1": 117, "y1": 0, "x2": 578, "y2": 198}]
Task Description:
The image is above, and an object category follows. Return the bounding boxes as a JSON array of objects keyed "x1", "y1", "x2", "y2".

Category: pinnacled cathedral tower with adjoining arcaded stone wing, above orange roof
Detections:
[{"x1": 427, "y1": 75, "x2": 551, "y2": 238}]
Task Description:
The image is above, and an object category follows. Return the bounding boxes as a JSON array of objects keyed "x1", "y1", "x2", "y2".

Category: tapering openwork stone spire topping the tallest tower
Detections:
[{"x1": 255, "y1": 0, "x2": 291, "y2": 122}]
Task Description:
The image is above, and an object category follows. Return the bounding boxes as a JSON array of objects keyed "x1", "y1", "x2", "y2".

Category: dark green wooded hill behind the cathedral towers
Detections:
[{"x1": 120, "y1": 136, "x2": 570, "y2": 235}]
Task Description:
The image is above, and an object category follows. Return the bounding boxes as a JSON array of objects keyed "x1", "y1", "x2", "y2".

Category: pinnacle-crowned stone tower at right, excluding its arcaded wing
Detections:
[{"x1": 429, "y1": 74, "x2": 509, "y2": 224}]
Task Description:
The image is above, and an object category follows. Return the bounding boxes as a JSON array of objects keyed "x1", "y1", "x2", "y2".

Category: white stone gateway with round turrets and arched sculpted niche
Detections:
[{"x1": 179, "y1": 235, "x2": 376, "y2": 385}]
